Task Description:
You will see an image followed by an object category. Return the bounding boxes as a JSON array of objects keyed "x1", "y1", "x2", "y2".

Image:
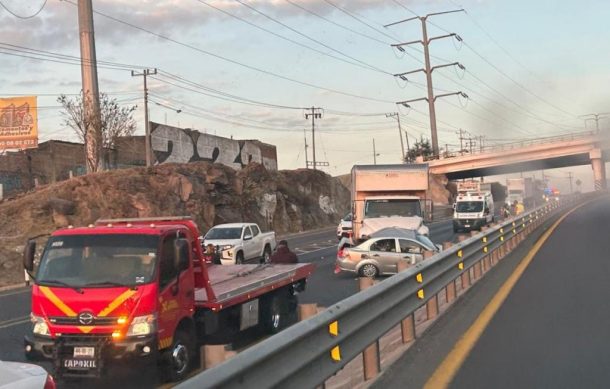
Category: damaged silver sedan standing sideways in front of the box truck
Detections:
[{"x1": 335, "y1": 227, "x2": 441, "y2": 278}]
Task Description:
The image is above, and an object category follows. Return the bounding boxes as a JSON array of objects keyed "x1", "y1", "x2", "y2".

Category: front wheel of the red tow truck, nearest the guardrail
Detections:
[{"x1": 161, "y1": 330, "x2": 194, "y2": 382}]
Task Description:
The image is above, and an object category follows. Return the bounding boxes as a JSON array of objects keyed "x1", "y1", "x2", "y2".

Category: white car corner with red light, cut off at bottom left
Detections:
[{"x1": 0, "y1": 361, "x2": 55, "y2": 389}]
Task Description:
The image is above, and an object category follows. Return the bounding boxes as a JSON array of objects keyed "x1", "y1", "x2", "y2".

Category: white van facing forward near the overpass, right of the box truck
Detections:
[{"x1": 453, "y1": 192, "x2": 495, "y2": 232}]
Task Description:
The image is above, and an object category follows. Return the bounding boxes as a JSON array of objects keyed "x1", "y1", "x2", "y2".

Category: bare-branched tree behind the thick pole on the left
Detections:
[{"x1": 57, "y1": 91, "x2": 138, "y2": 166}]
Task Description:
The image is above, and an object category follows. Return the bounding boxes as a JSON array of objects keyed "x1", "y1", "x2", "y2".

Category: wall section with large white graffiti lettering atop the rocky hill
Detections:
[{"x1": 151, "y1": 123, "x2": 277, "y2": 170}]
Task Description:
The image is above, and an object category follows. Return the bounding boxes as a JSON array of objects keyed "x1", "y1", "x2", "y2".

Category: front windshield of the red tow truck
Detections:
[{"x1": 36, "y1": 234, "x2": 159, "y2": 288}]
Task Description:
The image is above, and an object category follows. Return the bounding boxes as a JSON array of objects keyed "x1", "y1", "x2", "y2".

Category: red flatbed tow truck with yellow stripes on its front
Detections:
[{"x1": 24, "y1": 217, "x2": 314, "y2": 381}]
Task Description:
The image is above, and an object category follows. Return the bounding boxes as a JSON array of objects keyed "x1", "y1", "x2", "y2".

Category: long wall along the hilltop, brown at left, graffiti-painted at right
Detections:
[{"x1": 0, "y1": 123, "x2": 277, "y2": 197}]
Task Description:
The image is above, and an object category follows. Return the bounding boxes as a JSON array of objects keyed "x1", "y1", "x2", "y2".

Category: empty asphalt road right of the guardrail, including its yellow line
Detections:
[{"x1": 373, "y1": 197, "x2": 610, "y2": 389}]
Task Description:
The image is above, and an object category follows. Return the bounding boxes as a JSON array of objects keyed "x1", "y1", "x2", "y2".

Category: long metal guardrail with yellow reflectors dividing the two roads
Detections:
[{"x1": 177, "y1": 196, "x2": 586, "y2": 388}]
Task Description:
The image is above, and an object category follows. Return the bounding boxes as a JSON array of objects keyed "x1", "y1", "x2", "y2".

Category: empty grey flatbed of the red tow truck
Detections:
[{"x1": 195, "y1": 263, "x2": 314, "y2": 308}]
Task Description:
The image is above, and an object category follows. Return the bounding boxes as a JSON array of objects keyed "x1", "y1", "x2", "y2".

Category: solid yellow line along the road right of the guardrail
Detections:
[{"x1": 424, "y1": 200, "x2": 595, "y2": 389}]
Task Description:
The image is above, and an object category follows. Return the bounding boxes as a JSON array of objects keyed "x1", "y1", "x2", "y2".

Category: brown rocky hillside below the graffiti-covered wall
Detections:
[{"x1": 0, "y1": 162, "x2": 350, "y2": 286}]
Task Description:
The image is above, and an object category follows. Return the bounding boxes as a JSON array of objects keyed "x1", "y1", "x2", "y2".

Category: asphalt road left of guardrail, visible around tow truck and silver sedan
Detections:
[{"x1": 0, "y1": 221, "x2": 455, "y2": 388}]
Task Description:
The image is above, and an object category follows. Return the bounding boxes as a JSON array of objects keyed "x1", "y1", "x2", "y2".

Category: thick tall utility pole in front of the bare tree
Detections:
[{"x1": 77, "y1": 0, "x2": 103, "y2": 173}]
